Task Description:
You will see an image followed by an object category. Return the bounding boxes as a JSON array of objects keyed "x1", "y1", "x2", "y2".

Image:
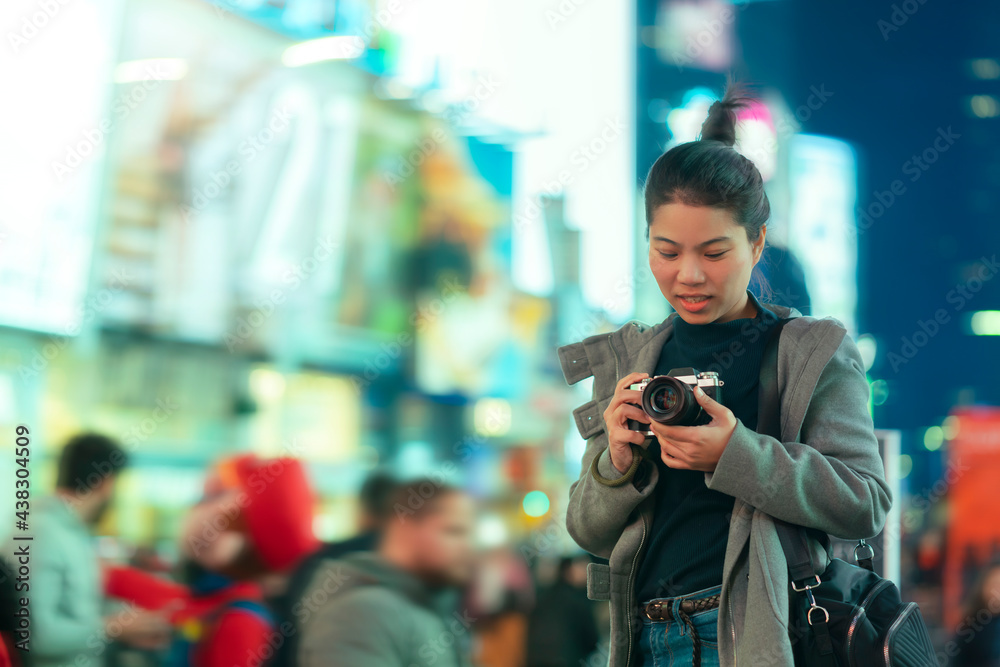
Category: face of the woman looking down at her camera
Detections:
[{"x1": 649, "y1": 203, "x2": 767, "y2": 324}]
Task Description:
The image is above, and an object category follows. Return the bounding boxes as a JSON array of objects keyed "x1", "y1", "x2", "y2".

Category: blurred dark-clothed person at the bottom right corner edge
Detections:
[{"x1": 952, "y1": 560, "x2": 1000, "y2": 667}]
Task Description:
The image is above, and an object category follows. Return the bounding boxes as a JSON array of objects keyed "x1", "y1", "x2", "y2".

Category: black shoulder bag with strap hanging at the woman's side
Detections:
[{"x1": 757, "y1": 319, "x2": 938, "y2": 667}]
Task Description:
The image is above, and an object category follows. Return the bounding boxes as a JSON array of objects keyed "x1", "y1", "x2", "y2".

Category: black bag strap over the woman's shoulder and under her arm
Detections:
[{"x1": 757, "y1": 318, "x2": 816, "y2": 583}]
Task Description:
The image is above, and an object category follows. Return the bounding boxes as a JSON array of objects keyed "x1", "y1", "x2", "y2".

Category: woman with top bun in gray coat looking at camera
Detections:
[{"x1": 560, "y1": 91, "x2": 891, "y2": 667}]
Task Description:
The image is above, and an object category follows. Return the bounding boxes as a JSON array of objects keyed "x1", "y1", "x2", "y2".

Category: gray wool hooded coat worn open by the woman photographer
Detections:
[{"x1": 559, "y1": 304, "x2": 892, "y2": 667}]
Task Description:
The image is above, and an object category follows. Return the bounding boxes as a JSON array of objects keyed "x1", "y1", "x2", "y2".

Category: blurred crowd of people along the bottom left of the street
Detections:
[{"x1": 0, "y1": 433, "x2": 606, "y2": 667}]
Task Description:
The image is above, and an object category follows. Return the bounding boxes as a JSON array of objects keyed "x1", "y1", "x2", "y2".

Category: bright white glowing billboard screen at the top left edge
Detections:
[{"x1": 0, "y1": 0, "x2": 118, "y2": 336}]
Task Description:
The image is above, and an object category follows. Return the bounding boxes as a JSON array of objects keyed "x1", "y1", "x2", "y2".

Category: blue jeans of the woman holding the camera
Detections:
[{"x1": 636, "y1": 585, "x2": 722, "y2": 667}]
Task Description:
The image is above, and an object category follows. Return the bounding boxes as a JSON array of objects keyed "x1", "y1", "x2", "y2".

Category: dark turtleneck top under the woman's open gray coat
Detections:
[{"x1": 635, "y1": 291, "x2": 778, "y2": 602}]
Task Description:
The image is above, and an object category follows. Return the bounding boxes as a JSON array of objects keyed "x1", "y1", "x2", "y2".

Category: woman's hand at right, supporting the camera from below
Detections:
[{"x1": 652, "y1": 387, "x2": 736, "y2": 472}]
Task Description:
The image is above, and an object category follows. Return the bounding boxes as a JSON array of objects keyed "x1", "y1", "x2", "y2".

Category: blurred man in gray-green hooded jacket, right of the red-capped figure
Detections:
[{"x1": 296, "y1": 479, "x2": 476, "y2": 667}]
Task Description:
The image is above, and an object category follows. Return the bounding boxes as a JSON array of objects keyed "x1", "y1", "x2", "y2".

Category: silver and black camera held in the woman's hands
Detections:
[{"x1": 628, "y1": 368, "x2": 724, "y2": 436}]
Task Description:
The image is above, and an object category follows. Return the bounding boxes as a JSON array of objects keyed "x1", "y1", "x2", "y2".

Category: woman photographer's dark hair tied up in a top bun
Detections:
[{"x1": 645, "y1": 82, "x2": 771, "y2": 243}]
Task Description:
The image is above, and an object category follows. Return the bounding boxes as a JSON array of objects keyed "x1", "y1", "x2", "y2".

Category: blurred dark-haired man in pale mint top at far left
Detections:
[{"x1": 15, "y1": 433, "x2": 170, "y2": 667}]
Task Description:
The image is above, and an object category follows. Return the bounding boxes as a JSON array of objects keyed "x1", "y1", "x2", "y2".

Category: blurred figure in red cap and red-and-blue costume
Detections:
[{"x1": 106, "y1": 455, "x2": 319, "y2": 667}]
